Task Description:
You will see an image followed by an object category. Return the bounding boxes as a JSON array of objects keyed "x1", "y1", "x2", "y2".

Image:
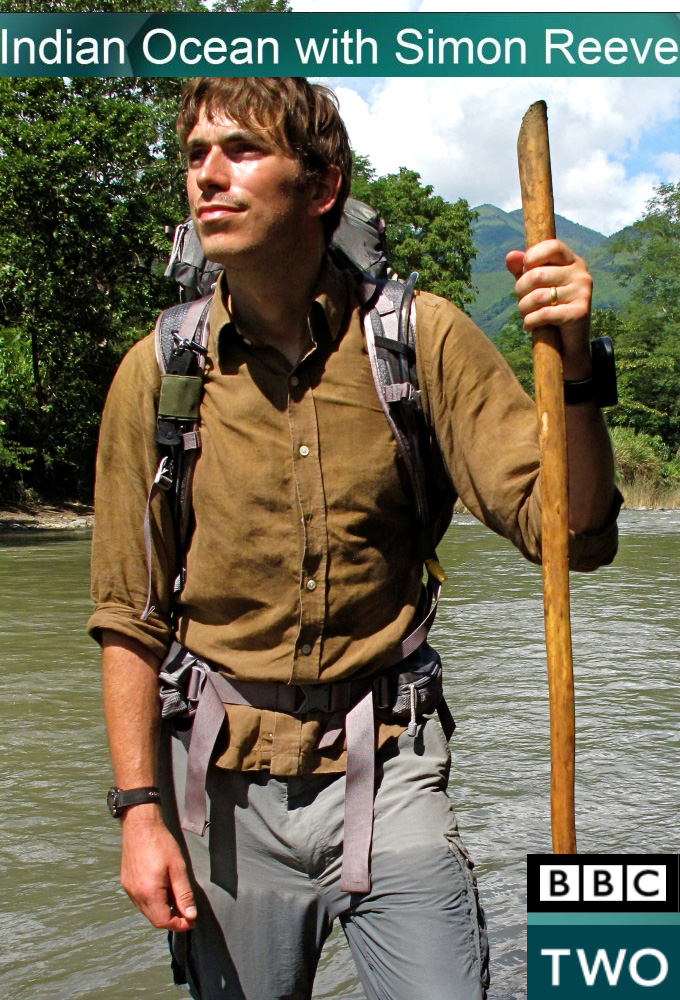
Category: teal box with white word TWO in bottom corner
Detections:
[{"x1": 527, "y1": 914, "x2": 680, "y2": 1000}]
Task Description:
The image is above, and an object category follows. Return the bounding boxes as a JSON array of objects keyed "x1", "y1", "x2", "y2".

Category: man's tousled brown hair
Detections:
[{"x1": 177, "y1": 77, "x2": 352, "y2": 242}]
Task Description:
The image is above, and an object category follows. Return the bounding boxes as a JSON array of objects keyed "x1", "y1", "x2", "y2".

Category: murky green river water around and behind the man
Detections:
[{"x1": 0, "y1": 511, "x2": 680, "y2": 1000}]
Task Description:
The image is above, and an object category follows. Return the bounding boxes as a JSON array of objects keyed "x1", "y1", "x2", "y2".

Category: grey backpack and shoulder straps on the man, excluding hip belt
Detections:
[{"x1": 141, "y1": 198, "x2": 451, "y2": 627}]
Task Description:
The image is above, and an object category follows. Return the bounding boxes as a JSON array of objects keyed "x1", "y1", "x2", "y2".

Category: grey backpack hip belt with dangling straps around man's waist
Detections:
[{"x1": 159, "y1": 627, "x2": 455, "y2": 892}]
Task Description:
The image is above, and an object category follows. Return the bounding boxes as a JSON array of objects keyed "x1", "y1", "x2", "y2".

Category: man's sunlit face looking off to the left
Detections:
[{"x1": 186, "y1": 110, "x2": 318, "y2": 265}]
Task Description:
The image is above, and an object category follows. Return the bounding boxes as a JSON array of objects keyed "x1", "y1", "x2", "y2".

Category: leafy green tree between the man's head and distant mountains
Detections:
[{"x1": 352, "y1": 154, "x2": 476, "y2": 309}]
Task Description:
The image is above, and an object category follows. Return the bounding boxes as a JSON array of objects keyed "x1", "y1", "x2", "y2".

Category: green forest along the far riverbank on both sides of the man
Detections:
[{"x1": 0, "y1": 0, "x2": 680, "y2": 505}]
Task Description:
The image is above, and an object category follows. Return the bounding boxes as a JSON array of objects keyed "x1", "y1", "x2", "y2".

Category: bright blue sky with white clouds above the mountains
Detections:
[{"x1": 284, "y1": 0, "x2": 680, "y2": 235}]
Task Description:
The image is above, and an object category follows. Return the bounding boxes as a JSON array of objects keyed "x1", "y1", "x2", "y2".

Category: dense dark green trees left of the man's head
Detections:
[{"x1": 0, "y1": 0, "x2": 288, "y2": 498}]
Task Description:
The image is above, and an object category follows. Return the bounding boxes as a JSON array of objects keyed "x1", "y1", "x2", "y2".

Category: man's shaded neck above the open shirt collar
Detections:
[{"x1": 225, "y1": 240, "x2": 323, "y2": 365}]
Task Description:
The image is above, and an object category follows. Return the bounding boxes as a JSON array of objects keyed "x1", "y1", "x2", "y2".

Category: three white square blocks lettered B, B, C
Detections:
[{"x1": 539, "y1": 864, "x2": 666, "y2": 903}]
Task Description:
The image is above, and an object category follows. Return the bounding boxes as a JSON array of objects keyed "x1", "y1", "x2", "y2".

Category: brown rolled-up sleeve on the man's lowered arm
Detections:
[{"x1": 87, "y1": 337, "x2": 175, "y2": 657}]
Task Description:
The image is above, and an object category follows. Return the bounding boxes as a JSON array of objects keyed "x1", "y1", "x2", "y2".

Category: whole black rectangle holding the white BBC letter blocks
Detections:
[{"x1": 527, "y1": 854, "x2": 680, "y2": 913}]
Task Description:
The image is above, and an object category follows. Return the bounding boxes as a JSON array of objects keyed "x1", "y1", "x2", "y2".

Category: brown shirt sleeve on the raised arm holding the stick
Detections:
[{"x1": 416, "y1": 294, "x2": 621, "y2": 571}]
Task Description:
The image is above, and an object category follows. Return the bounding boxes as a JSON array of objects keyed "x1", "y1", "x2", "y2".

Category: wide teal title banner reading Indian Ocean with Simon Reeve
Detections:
[{"x1": 0, "y1": 12, "x2": 680, "y2": 77}]
